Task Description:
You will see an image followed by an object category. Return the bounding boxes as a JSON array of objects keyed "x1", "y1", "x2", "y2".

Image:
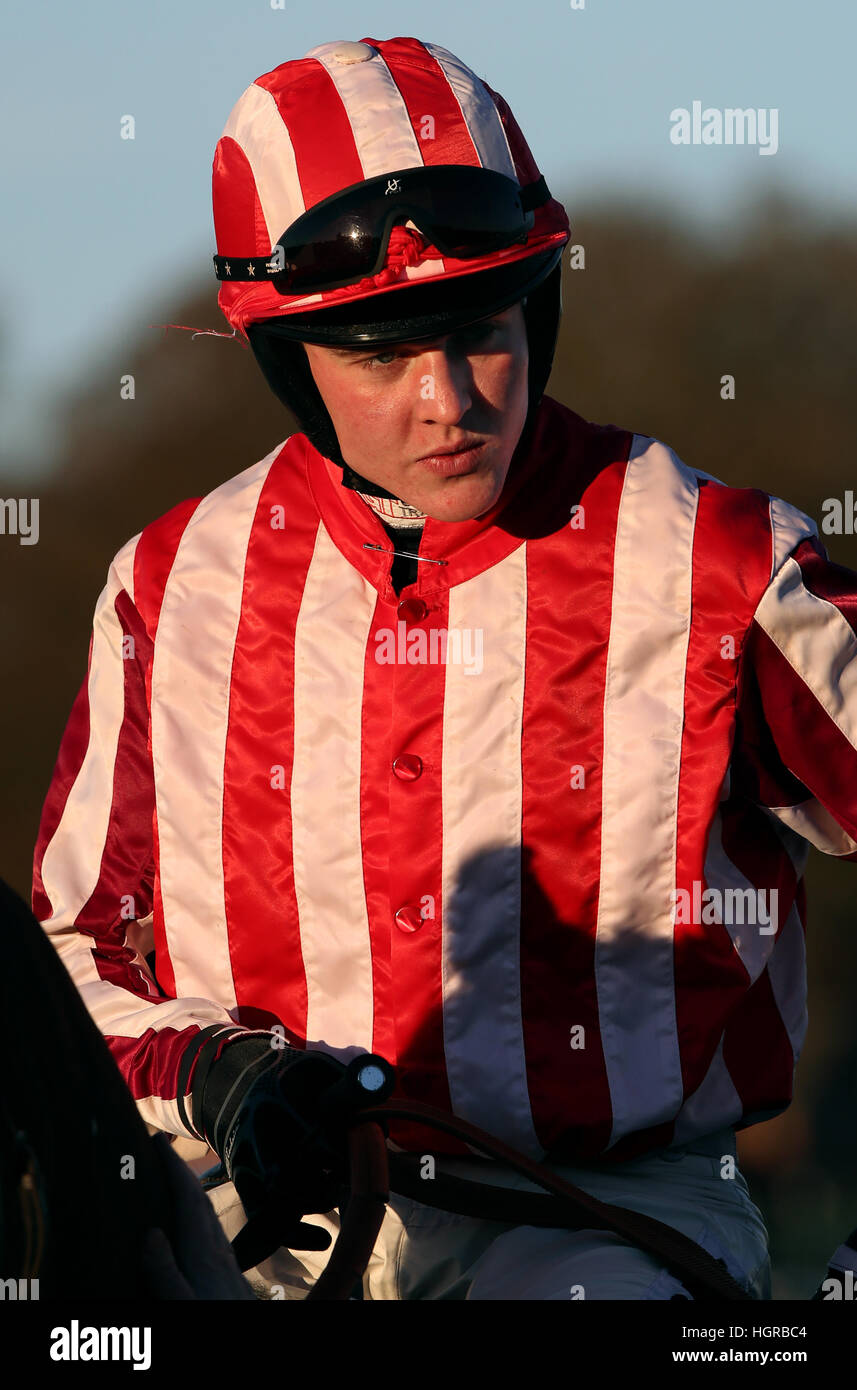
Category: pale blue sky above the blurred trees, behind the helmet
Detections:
[{"x1": 0, "y1": 0, "x2": 857, "y2": 477}]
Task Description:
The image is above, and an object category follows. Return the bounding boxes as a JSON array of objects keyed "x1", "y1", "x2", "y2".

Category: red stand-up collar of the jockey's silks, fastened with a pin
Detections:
[{"x1": 303, "y1": 396, "x2": 589, "y2": 603}]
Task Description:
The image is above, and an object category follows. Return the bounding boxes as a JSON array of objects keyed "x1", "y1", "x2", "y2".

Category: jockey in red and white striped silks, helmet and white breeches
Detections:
[{"x1": 33, "y1": 38, "x2": 857, "y2": 1300}]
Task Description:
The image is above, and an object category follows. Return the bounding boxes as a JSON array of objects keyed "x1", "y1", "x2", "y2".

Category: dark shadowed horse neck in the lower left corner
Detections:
[{"x1": 0, "y1": 878, "x2": 172, "y2": 1300}]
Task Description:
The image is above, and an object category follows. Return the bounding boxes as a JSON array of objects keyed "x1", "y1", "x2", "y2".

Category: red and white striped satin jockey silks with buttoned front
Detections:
[{"x1": 33, "y1": 398, "x2": 857, "y2": 1161}]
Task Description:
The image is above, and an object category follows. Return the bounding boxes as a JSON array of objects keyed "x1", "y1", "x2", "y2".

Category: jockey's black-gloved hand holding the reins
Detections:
[{"x1": 194, "y1": 1037, "x2": 347, "y2": 1269}]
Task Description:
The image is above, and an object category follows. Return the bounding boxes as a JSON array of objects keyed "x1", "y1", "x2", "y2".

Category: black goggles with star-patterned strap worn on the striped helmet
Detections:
[{"x1": 214, "y1": 164, "x2": 550, "y2": 295}]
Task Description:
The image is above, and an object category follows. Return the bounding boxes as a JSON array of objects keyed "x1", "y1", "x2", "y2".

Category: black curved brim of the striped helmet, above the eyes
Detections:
[{"x1": 244, "y1": 246, "x2": 563, "y2": 348}]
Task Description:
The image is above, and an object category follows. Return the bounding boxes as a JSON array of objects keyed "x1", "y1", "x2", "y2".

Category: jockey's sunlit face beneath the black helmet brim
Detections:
[{"x1": 304, "y1": 303, "x2": 529, "y2": 521}]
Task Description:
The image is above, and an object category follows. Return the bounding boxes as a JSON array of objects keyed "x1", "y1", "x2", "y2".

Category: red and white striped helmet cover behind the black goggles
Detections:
[{"x1": 213, "y1": 38, "x2": 569, "y2": 336}]
